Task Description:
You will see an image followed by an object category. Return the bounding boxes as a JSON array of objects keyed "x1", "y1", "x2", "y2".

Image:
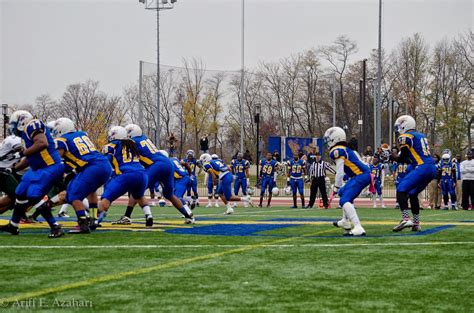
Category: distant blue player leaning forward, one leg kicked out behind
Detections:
[{"x1": 199, "y1": 153, "x2": 252, "y2": 214}]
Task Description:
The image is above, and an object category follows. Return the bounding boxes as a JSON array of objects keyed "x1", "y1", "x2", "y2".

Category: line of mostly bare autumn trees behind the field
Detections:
[{"x1": 12, "y1": 30, "x2": 474, "y2": 158}]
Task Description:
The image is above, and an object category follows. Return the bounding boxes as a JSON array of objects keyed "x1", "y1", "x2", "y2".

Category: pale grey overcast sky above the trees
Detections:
[{"x1": 0, "y1": 0, "x2": 474, "y2": 104}]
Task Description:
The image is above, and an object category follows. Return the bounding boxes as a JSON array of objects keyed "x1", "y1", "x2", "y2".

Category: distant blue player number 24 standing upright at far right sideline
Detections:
[{"x1": 438, "y1": 153, "x2": 457, "y2": 210}]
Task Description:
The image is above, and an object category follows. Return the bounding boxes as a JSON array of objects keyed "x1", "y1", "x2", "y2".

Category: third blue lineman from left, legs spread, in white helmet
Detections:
[{"x1": 98, "y1": 126, "x2": 153, "y2": 227}]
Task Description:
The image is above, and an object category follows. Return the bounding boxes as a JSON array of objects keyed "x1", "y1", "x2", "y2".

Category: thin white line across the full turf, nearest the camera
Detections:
[{"x1": 0, "y1": 241, "x2": 474, "y2": 249}]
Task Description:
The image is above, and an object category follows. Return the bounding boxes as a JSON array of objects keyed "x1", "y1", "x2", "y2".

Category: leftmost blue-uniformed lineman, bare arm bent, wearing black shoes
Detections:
[{"x1": 0, "y1": 111, "x2": 64, "y2": 238}]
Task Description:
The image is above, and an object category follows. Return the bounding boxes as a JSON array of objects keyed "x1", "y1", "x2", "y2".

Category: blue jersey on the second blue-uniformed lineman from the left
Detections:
[{"x1": 55, "y1": 131, "x2": 107, "y2": 170}]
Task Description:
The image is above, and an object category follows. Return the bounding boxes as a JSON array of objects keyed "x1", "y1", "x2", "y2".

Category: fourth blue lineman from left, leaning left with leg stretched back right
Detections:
[{"x1": 119, "y1": 124, "x2": 194, "y2": 224}]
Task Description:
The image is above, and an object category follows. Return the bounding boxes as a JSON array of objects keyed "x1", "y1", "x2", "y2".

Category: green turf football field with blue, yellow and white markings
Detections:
[{"x1": 0, "y1": 206, "x2": 474, "y2": 312}]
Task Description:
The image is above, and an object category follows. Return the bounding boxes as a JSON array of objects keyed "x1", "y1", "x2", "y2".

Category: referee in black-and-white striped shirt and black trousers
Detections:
[{"x1": 307, "y1": 152, "x2": 336, "y2": 209}]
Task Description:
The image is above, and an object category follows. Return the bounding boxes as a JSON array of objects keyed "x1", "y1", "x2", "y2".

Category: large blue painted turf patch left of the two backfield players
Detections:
[{"x1": 165, "y1": 224, "x2": 300, "y2": 236}]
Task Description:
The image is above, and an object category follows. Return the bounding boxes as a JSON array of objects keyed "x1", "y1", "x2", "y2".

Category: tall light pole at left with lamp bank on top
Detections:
[{"x1": 138, "y1": 0, "x2": 178, "y2": 147}]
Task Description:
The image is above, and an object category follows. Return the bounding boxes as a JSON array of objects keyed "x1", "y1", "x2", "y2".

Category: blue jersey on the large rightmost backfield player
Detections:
[{"x1": 398, "y1": 132, "x2": 434, "y2": 165}]
